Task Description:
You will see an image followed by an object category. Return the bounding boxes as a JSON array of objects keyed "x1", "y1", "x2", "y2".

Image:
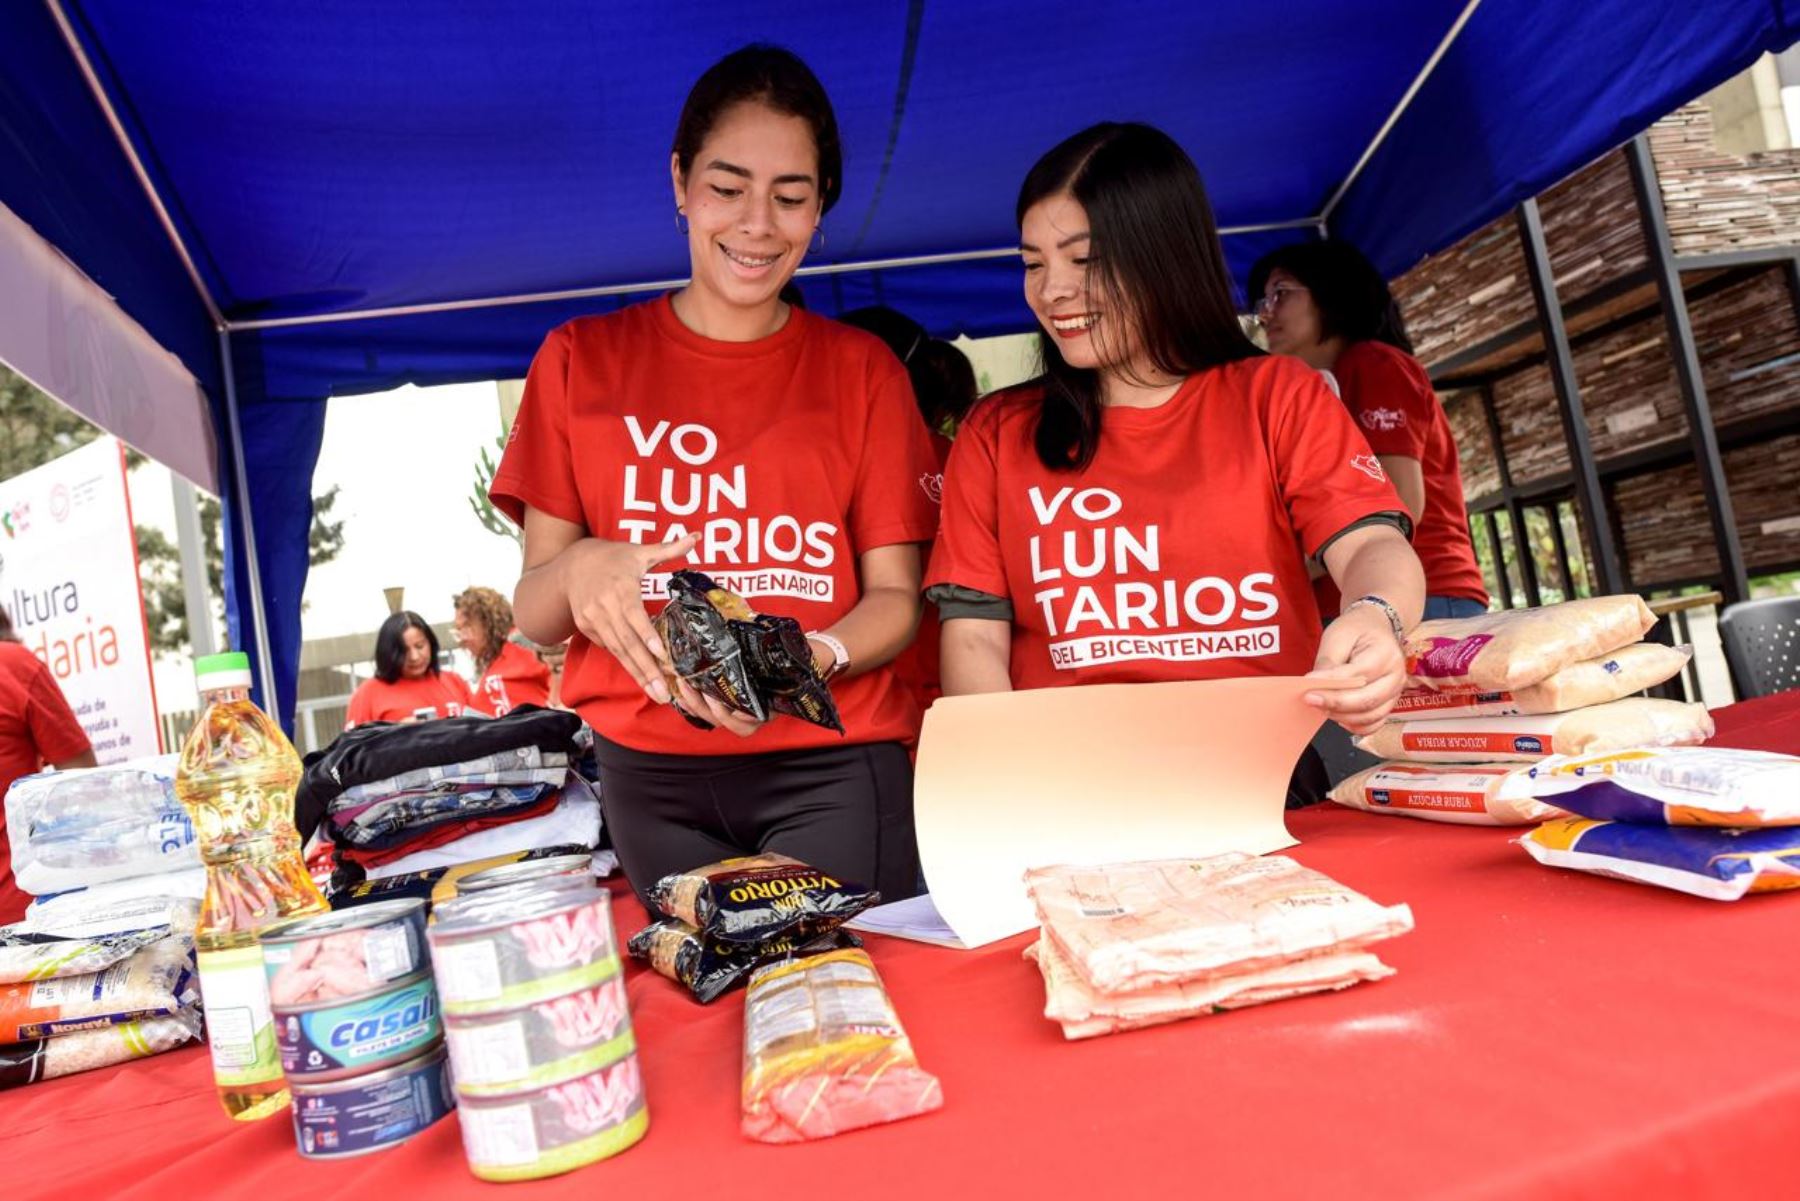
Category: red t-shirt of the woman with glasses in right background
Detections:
[{"x1": 1318, "y1": 342, "x2": 1487, "y2": 616}]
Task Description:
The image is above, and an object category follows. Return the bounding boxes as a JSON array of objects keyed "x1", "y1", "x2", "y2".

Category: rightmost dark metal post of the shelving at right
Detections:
[{"x1": 1625, "y1": 133, "x2": 1750, "y2": 605}]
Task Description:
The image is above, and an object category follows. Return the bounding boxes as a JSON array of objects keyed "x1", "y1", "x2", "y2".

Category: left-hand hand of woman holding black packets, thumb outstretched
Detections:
[{"x1": 558, "y1": 535, "x2": 706, "y2": 705}]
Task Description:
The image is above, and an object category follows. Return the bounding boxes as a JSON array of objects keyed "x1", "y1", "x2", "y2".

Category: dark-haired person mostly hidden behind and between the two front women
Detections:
[{"x1": 841, "y1": 304, "x2": 977, "y2": 708}]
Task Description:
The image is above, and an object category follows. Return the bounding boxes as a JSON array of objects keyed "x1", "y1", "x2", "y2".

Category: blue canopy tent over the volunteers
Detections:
[{"x1": 0, "y1": 0, "x2": 1800, "y2": 718}]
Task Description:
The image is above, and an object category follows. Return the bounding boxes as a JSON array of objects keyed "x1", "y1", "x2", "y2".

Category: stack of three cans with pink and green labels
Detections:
[{"x1": 427, "y1": 870, "x2": 650, "y2": 1181}]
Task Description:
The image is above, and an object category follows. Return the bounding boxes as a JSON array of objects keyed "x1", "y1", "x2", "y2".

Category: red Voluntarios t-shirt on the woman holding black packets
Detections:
[{"x1": 488, "y1": 297, "x2": 938, "y2": 754}]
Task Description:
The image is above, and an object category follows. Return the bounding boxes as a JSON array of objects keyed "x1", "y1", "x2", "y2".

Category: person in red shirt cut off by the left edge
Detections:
[{"x1": 0, "y1": 607, "x2": 94, "y2": 926}]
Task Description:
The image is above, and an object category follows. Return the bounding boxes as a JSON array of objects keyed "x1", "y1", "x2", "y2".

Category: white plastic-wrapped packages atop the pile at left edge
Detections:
[{"x1": 5, "y1": 754, "x2": 207, "y2": 933}]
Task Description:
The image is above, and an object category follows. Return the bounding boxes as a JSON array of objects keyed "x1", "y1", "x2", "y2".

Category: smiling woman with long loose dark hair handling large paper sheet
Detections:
[{"x1": 925, "y1": 122, "x2": 1424, "y2": 805}]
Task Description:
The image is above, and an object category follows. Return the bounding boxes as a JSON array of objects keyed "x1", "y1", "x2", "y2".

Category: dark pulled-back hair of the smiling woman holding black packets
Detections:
[{"x1": 673, "y1": 43, "x2": 844, "y2": 212}]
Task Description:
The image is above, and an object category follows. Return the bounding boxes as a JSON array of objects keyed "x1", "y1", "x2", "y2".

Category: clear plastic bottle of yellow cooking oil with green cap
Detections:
[{"x1": 175, "y1": 652, "x2": 329, "y2": 1122}]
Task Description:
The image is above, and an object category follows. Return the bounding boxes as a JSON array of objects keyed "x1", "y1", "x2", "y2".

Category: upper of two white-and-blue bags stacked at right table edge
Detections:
[{"x1": 1505, "y1": 747, "x2": 1800, "y2": 826}]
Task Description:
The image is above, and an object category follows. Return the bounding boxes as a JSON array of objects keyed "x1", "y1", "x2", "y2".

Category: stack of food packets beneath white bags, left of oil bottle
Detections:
[{"x1": 0, "y1": 900, "x2": 200, "y2": 1089}]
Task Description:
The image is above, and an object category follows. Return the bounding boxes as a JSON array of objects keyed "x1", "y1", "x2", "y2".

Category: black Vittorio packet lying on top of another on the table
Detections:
[{"x1": 650, "y1": 855, "x2": 880, "y2": 944}]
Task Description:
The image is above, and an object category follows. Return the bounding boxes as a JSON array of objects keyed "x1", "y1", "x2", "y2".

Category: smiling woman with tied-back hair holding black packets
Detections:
[{"x1": 490, "y1": 45, "x2": 936, "y2": 900}]
